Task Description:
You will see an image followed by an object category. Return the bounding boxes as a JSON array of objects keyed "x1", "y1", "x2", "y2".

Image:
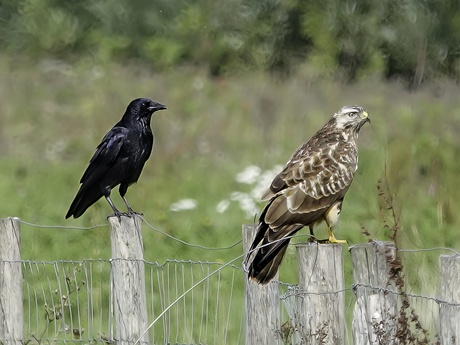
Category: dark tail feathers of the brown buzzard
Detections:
[{"x1": 246, "y1": 222, "x2": 290, "y2": 284}]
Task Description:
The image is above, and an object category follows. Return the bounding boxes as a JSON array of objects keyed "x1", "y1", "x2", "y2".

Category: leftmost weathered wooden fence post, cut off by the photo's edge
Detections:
[{"x1": 0, "y1": 218, "x2": 24, "y2": 345}]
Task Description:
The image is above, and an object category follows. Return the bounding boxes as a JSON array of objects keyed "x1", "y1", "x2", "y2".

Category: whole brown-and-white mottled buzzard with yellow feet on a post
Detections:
[{"x1": 245, "y1": 106, "x2": 370, "y2": 284}]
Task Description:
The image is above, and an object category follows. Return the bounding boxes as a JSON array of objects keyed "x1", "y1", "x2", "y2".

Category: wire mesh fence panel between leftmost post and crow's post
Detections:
[{"x1": 23, "y1": 260, "x2": 114, "y2": 343}]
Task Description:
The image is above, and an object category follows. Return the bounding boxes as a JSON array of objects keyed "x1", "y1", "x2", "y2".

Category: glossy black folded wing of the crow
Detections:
[{"x1": 80, "y1": 127, "x2": 128, "y2": 188}]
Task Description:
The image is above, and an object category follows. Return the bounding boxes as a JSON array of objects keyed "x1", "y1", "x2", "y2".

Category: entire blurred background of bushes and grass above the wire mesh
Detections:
[{"x1": 0, "y1": 0, "x2": 460, "y2": 338}]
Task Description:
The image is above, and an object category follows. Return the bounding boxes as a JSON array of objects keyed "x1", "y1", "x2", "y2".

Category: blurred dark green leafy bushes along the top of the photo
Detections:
[{"x1": 0, "y1": 0, "x2": 460, "y2": 82}]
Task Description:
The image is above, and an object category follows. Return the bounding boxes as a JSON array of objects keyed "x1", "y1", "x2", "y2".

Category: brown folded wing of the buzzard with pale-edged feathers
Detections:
[{"x1": 264, "y1": 140, "x2": 358, "y2": 231}]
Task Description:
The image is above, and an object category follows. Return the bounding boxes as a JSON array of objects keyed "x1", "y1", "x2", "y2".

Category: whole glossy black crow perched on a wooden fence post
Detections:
[{"x1": 66, "y1": 98, "x2": 166, "y2": 218}]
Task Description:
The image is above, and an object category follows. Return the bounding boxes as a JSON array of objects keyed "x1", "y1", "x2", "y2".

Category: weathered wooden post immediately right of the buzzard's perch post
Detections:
[{"x1": 349, "y1": 241, "x2": 398, "y2": 345}]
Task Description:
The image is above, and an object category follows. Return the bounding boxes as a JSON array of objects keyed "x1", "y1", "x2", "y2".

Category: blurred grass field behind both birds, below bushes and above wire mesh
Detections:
[{"x1": 0, "y1": 57, "x2": 460, "y2": 340}]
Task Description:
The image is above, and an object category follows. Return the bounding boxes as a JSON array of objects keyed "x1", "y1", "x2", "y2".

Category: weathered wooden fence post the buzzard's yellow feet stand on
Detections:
[{"x1": 295, "y1": 243, "x2": 345, "y2": 345}]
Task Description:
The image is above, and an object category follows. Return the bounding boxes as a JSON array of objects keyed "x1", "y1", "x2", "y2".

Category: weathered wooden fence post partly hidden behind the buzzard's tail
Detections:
[{"x1": 243, "y1": 225, "x2": 280, "y2": 345}]
